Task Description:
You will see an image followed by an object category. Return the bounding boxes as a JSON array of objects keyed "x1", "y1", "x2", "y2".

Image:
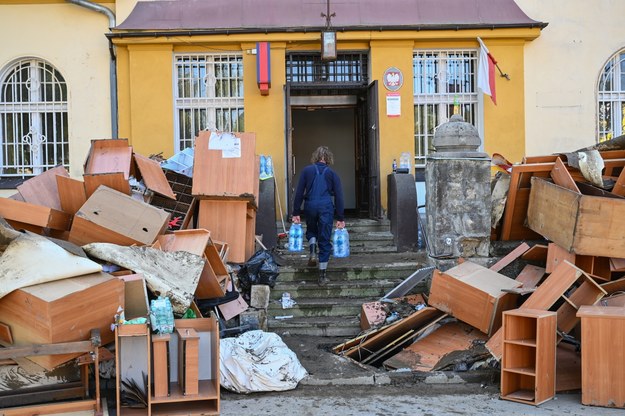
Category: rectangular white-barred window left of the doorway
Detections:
[{"x1": 174, "y1": 53, "x2": 245, "y2": 152}]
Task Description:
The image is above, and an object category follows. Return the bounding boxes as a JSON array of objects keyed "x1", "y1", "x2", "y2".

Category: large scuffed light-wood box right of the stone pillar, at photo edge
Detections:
[{"x1": 527, "y1": 177, "x2": 625, "y2": 257}]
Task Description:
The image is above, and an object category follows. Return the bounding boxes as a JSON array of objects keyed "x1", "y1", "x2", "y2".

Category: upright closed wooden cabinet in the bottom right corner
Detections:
[{"x1": 577, "y1": 306, "x2": 625, "y2": 408}]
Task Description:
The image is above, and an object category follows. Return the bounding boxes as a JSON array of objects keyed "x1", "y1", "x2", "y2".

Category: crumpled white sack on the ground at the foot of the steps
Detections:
[{"x1": 219, "y1": 330, "x2": 308, "y2": 393}]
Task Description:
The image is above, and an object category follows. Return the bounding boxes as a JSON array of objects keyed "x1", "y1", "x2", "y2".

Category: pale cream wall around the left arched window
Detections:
[{"x1": 0, "y1": 2, "x2": 114, "y2": 179}]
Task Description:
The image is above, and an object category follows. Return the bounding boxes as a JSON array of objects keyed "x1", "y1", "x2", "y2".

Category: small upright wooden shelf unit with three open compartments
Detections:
[{"x1": 501, "y1": 309, "x2": 557, "y2": 405}]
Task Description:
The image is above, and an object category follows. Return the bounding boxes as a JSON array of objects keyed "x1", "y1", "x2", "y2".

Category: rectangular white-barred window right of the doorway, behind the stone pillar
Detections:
[{"x1": 412, "y1": 50, "x2": 481, "y2": 168}]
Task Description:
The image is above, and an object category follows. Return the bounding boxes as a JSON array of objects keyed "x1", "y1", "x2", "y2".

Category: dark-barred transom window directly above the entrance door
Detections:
[{"x1": 286, "y1": 52, "x2": 369, "y2": 88}]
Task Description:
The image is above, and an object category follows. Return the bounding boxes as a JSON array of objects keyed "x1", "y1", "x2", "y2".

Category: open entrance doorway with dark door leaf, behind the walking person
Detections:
[{"x1": 285, "y1": 82, "x2": 381, "y2": 219}]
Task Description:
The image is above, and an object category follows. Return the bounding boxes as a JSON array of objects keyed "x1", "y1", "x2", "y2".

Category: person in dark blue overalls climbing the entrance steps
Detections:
[{"x1": 292, "y1": 146, "x2": 345, "y2": 285}]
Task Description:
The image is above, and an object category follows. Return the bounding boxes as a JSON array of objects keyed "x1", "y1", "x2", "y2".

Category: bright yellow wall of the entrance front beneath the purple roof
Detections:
[{"x1": 114, "y1": 29, "x2": 540, "y2": 214}]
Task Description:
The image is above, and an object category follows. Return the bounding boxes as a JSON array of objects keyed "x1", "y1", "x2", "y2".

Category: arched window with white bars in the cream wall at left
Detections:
[{"x1": 0, "y1": 58, "x2": 69, "y2": 178}]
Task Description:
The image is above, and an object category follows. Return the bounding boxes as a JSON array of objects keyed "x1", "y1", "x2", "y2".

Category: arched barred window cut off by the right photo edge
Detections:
[{"x1": 597, "y1": 50, "x2": 625, "y2": 142}]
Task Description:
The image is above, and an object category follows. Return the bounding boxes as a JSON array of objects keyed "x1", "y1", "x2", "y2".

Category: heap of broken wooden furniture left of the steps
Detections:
[{"x1": 0, "y1": 132, "x2": 259, "y2": 415}]
